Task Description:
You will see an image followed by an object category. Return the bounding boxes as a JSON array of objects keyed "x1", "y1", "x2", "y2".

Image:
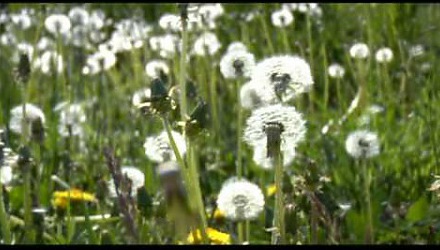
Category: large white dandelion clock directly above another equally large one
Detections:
[{"x1": 251, "y1": 55, "x2": 313, "y2": 102}]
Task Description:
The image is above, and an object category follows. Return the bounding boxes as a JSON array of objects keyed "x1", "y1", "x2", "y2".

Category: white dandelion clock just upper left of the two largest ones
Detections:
[{"x1": 220, "y1": 50, "x2": 255, "y2": 79}]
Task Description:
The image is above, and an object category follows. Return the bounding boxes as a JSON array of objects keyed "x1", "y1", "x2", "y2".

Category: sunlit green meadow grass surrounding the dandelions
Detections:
[{"x1": 0, "y1": 3, "x2": 440, "y2": 244}]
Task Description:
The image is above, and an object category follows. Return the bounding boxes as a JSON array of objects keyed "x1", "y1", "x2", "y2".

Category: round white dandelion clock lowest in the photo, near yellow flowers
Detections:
[{"x1": 217, "y1": 177, "x2": 264, "y2": 221}]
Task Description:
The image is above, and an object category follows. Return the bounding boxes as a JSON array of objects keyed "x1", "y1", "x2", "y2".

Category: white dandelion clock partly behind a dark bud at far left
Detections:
[{"x1": 9, "y1": 103, "x2": 46, "y2": 134}]
